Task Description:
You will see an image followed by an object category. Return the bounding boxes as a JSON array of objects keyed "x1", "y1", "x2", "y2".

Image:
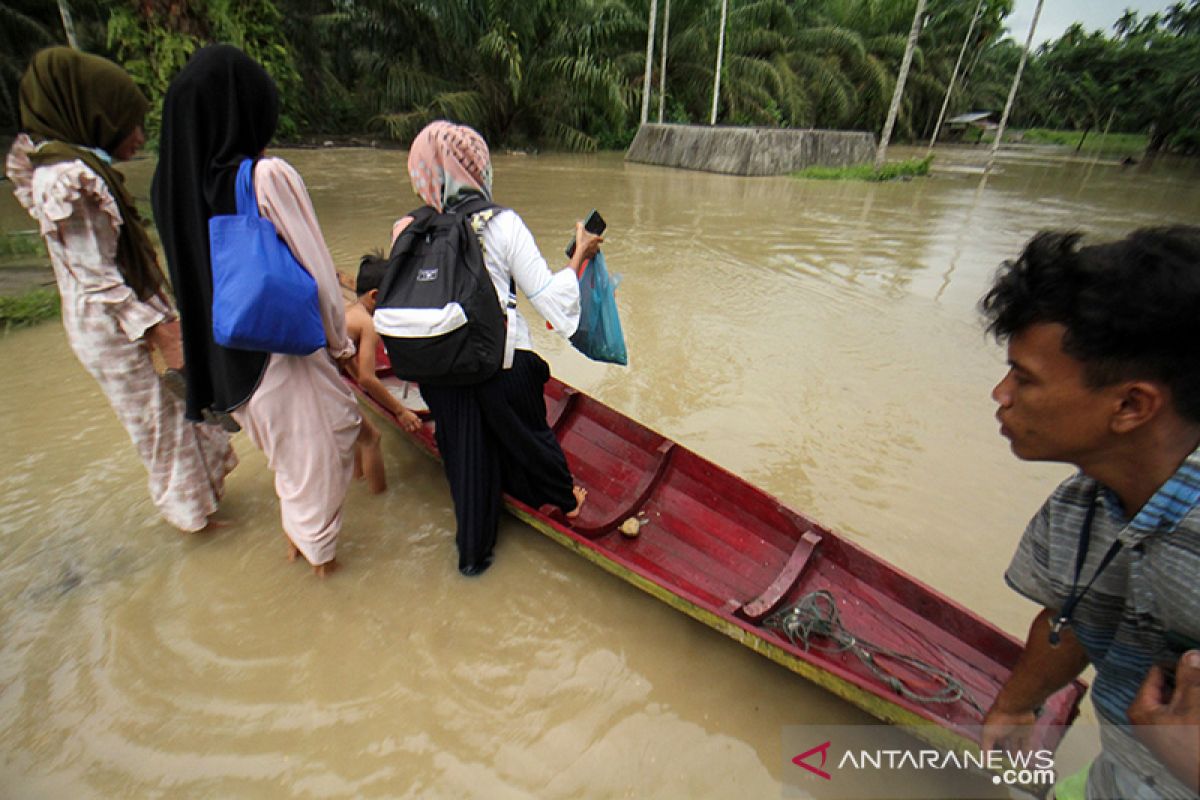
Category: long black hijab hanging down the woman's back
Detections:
[{"x1": 150, "y1": 44, "x2": 280, "y2": 421}]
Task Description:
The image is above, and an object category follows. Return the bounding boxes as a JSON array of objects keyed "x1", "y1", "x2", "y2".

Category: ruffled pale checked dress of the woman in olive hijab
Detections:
[{"x1": 6, "y1": 134, "x2": 238, "y2": 531}]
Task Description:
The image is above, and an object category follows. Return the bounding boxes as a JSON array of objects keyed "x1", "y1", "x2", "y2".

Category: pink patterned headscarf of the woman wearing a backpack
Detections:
[{"x1": 408, "y1": 120, "x2": 492, "y2": 212}]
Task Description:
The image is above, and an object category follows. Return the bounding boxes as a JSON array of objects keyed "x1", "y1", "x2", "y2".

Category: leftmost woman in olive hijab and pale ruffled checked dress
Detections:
[{"x1": 6, "y1": 47, "x2": 238, "y2": 530}]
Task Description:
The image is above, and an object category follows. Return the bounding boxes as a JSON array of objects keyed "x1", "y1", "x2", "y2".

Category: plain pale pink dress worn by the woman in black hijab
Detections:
[{"x1": 233, "y1": 158, "x2": 362, "y2": 565}]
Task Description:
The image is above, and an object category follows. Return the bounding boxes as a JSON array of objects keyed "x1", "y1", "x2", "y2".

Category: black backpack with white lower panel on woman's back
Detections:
[{"x1": 374, "y1": 197, "x2": 516, "y2": 386}]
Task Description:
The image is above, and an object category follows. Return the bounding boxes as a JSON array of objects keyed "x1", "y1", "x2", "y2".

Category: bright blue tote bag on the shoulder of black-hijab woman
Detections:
[{"x1": 209, "y1": 158, "x2": 325, "y2": 355}]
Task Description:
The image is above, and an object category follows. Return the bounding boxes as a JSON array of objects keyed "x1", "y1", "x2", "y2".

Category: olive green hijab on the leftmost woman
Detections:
[{"x1": 20, "y1": 47, "x2": 166, "y2": 300}]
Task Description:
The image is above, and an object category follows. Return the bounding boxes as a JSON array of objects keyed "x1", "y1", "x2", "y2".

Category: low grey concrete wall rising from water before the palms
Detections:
[{"x1": 625, "y1": 124, "x2": 875, "y2": 175}]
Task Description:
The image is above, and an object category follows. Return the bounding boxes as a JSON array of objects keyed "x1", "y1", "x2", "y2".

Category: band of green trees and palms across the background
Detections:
[{"x1": 0, "y1": 0, "x2": 1200, "y2": 158}]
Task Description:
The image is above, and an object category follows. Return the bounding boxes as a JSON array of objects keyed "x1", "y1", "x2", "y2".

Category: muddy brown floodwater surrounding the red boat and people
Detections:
[{"x1": 0, "y1": 143, "x2": 1200, "y2": 798}]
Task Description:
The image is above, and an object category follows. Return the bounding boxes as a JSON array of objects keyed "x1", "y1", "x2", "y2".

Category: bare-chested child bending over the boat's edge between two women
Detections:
[{"x1": 344, "y1": 255, "x2": 421, "y2": 493}]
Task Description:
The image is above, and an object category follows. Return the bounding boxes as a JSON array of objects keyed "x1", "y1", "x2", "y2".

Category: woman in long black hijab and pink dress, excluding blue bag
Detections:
[{"x1": 151, "y1": 44, "x2": 362, "y2": 575}]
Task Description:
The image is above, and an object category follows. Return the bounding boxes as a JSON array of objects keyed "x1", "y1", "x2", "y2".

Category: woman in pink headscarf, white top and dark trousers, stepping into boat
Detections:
[{"x1": 388, "y1": 120, "x2": 601, "y2": 576}]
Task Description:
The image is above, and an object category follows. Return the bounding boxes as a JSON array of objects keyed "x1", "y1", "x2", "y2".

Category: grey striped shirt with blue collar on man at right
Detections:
[{"x1": 1004, "y1": 450, "x2": 1200, "y2": 800}]
